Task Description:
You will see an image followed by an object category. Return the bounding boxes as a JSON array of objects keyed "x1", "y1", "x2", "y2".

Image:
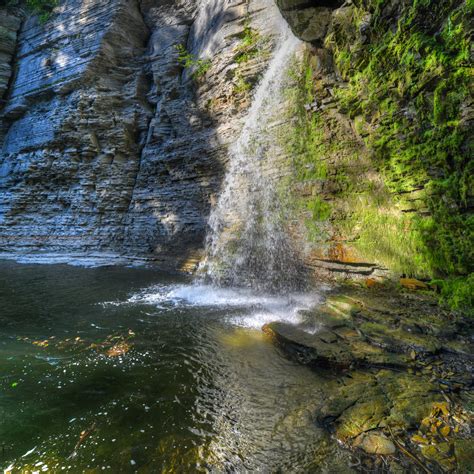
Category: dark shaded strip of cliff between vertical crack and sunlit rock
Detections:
[{"x1": 123, "y1": 1, "x2": 225, "y2": 270}]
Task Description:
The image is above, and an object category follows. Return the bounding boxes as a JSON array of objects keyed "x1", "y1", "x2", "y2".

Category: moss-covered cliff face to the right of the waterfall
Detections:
[{"x1": 279, "y1": 0, "x2": 474, "y2": 309}]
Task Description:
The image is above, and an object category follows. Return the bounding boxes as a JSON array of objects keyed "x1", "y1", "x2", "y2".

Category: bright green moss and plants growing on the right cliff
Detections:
[{"x1": 286, "y1": 0, "x2": 474, "y2": 310}]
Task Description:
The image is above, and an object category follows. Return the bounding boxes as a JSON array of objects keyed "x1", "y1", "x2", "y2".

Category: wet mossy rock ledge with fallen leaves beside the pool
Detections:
[{"x1": 263, "y1": 286, "x2": 474, "y2": 473}]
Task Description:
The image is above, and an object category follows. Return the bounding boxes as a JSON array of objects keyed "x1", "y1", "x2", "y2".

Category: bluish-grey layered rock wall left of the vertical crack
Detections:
[{"x1": 0, "y1": 0, "x2": 151, "y2": 251}]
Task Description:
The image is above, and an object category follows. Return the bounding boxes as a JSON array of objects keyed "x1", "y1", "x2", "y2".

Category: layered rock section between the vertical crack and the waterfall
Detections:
[{"x1": 124, "y1": 0, "x2": 286, "y2": 266}]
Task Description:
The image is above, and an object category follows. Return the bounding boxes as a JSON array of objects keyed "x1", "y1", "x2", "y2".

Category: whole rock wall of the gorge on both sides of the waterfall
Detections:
[{"x1": 0, "y1": 0, "x2": 474, "y2": 306}]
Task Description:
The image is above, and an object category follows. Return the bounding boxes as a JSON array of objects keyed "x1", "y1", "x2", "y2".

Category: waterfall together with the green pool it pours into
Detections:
[{"x1": 0, "y1": 14, "x2": 354, "y2": 473}]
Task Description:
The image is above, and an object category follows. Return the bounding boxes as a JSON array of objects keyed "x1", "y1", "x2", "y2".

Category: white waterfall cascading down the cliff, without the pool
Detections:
[{"x1": 204, "y1": 18, "x2": 303, "y2": 291}]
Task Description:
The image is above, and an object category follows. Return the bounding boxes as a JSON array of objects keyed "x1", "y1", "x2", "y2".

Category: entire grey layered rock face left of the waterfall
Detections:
[{"x1": 0, "y1": 0, "x2": 286, "y2": 261}]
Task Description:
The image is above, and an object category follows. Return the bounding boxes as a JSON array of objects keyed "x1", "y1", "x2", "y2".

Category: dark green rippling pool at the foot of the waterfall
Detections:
[{"x1": 0, "y1": 262, "x2": 348, "y2": 472}]
